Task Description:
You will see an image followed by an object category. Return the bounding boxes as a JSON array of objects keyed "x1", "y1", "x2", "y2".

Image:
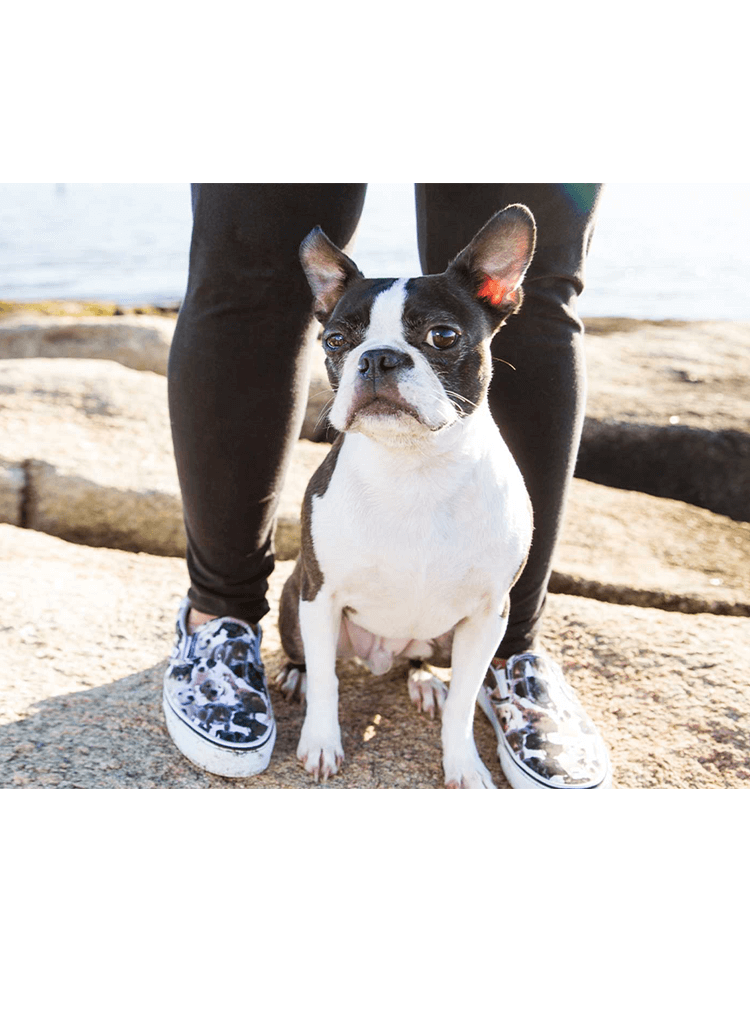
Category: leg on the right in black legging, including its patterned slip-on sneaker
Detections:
[{"x1": 417, "y1": 184, "x2": 611, "y2": 788}]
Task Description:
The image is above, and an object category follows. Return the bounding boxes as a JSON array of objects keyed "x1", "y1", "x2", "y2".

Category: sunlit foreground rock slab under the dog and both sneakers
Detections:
[{"x1": 0, "y1": 526, "x2": 750, "y2": 788}]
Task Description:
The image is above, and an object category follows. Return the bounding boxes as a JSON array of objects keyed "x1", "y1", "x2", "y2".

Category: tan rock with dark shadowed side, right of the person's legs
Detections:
[{"x1": 576, "y1": 319, "x2": 750, "y2": 522}]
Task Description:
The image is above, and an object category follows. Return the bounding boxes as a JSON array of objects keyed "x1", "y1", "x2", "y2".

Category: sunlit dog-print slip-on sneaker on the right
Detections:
[{"x1": 478, "y1": 652, "x2": 612, "y2": 789}]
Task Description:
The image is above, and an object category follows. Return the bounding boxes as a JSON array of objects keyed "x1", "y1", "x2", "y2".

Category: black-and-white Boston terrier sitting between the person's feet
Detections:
[{"x1": 279, "y1": 204, "x2": 536, "y2": 788}]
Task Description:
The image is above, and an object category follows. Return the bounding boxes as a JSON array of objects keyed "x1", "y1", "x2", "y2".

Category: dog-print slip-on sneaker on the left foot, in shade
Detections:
[{"x1": 164, "y1": 598, "x2": 276, "y2": 778}]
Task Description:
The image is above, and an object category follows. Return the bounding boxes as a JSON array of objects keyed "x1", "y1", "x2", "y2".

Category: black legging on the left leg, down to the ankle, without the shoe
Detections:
[{"x1": 169, "y1": 184, "x2": 366, "y2": 624}]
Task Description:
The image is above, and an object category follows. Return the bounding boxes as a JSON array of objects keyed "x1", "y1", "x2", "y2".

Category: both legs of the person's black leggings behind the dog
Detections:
[{"x1": 169, "y1": 184, "x2": 601, "y2": 657}]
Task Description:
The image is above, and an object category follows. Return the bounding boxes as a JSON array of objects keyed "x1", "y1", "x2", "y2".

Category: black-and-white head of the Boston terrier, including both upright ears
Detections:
[{"x1": 300, "y1": 204, "x2": 536, "y2": 442}]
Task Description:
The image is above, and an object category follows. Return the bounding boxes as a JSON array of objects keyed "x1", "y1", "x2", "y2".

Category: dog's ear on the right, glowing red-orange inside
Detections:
[{"x1": 446, "y1": 203, "x2": 536, "y2": 315}]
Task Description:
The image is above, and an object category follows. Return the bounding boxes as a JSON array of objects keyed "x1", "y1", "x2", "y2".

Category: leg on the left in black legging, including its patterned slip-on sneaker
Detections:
[{"x1": 163, "y1": 184, "x2": 365, "y2": 777}]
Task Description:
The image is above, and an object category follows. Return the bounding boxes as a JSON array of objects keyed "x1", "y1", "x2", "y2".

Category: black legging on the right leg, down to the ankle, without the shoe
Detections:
[{"x1": 417, "y1": 184, "x2": 601, "y2": 658}]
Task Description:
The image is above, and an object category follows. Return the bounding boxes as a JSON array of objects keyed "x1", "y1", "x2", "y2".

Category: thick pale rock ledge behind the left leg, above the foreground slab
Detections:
[{"x1": 0, "y1": 358, "x2": 326, "y2": 558}]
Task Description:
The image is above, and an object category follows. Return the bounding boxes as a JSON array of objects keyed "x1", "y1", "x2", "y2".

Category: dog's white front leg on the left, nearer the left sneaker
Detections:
[{"x1": 297, "y1": 590, "x2": 344, "y2": 781}]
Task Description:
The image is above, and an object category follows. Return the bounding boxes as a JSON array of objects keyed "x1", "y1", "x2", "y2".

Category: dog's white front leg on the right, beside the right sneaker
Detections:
[{"x1": 442, "y1": 609, "x2": 508, "y2": 788}]
